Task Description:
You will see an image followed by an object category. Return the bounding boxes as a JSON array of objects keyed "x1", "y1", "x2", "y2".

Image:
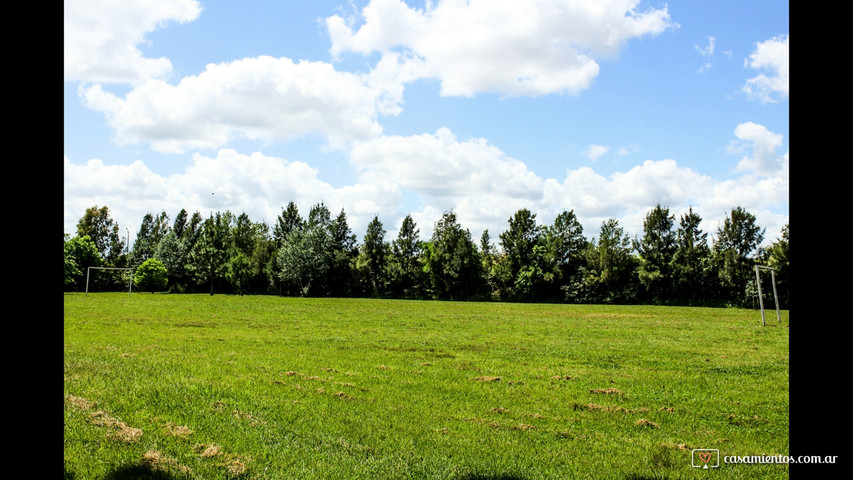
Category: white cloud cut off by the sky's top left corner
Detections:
[{"x1": 63, "y1": 0, "x2": 201, "y2": 83}]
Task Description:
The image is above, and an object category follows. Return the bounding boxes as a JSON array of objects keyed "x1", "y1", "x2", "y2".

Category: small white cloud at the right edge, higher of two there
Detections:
[{"x1": 743, "y1": 35, "x2": 790, "y2": 103}]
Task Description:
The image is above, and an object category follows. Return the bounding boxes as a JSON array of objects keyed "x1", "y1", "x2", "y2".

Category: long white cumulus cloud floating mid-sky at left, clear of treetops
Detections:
[{"x1": 80, "y1": 56, "x2": 401, "y2": 153}]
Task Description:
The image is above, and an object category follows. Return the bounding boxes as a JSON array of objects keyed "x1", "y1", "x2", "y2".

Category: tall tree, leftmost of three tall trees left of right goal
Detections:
[{"x1": 634, "y1": 204, "x2": 676, "y2": 302}]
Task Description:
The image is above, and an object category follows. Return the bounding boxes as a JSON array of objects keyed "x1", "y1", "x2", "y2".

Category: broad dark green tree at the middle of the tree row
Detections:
[{"x1": 424, "y1": 211, "x2": 485, "y2": 300}]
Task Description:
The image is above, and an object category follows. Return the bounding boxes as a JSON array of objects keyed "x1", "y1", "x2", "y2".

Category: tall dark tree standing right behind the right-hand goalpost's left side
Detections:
[{"x1": 714, "y1": 207, "x2": 764, "y2": 306}]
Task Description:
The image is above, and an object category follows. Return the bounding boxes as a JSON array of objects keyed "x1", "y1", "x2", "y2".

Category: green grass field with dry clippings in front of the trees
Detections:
[{"x1": 64, "y1": 292, "x2": 789, "y2": 480}]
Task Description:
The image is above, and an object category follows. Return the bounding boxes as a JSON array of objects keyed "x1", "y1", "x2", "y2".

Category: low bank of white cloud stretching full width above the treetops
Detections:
[{"x1": 65, "y1": 123, "x2": 789, "y2": 249}]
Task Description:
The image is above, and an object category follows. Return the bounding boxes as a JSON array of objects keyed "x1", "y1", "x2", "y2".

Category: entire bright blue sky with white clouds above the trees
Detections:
[{"x1": 64, "y1": 0, "x2": 789, "y2": 248}]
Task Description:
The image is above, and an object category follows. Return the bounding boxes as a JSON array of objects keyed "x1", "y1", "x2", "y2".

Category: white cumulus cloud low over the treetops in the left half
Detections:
[{"x1": 64, "y1": 149, "x2": 400, "y2": 234}]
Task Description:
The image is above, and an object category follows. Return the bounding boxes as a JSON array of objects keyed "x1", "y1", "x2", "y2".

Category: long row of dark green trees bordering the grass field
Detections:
[{"x1": 65, "y1": 202, "x2": 789, "y2": 308}]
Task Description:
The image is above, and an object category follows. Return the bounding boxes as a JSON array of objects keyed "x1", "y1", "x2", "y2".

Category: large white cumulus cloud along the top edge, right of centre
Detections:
[{"x1": 326, "y1": 0, "x2": 676, "y2": 96}]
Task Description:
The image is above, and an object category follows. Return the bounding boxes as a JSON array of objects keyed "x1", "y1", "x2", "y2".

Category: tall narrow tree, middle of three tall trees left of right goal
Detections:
[{"x1": 672, "y1": 207, "x2": 716, "y2": 304}]
